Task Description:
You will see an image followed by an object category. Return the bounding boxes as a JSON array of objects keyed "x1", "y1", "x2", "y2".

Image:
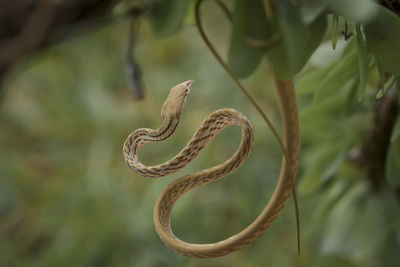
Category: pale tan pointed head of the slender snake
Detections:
[{"x1": 161, "y1": 80, "x2": 193, "y2": 119}]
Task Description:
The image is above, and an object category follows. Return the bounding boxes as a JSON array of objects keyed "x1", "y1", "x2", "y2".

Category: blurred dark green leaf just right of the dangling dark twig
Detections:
[{"x1": 149, "y1": 0, "x2": 190, "y2": 38}]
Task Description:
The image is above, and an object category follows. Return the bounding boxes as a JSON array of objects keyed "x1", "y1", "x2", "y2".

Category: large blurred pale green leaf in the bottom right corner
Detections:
[{"x1": 320, "y1": 182, "x2": 399, "y2": 260}]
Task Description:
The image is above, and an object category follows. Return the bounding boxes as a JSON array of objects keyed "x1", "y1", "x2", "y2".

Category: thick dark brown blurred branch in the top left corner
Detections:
[{"x1": 0, "y1": 0, "x2": 124, "y2": 82}]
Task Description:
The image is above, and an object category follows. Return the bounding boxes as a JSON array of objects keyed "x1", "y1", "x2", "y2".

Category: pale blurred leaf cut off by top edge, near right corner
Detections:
[{"x1": 322, "y1": 0, "x2": 376, "y2": 22}]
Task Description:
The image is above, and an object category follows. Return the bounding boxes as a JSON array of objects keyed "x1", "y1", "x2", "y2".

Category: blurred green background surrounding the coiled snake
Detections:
[{"x1": 0, "y1": 1, "x2": 400, "y2": 267}]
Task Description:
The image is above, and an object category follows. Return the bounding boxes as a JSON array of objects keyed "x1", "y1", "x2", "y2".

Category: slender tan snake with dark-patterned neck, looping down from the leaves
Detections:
[{"x1": 123, "y1": 80, "x2": 300, "y2": 258}]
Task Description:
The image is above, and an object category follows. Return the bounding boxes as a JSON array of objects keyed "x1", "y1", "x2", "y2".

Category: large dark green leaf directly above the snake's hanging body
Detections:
[{"x1": 267, "y1": 0, "x2": 327, "y2": 80}]
